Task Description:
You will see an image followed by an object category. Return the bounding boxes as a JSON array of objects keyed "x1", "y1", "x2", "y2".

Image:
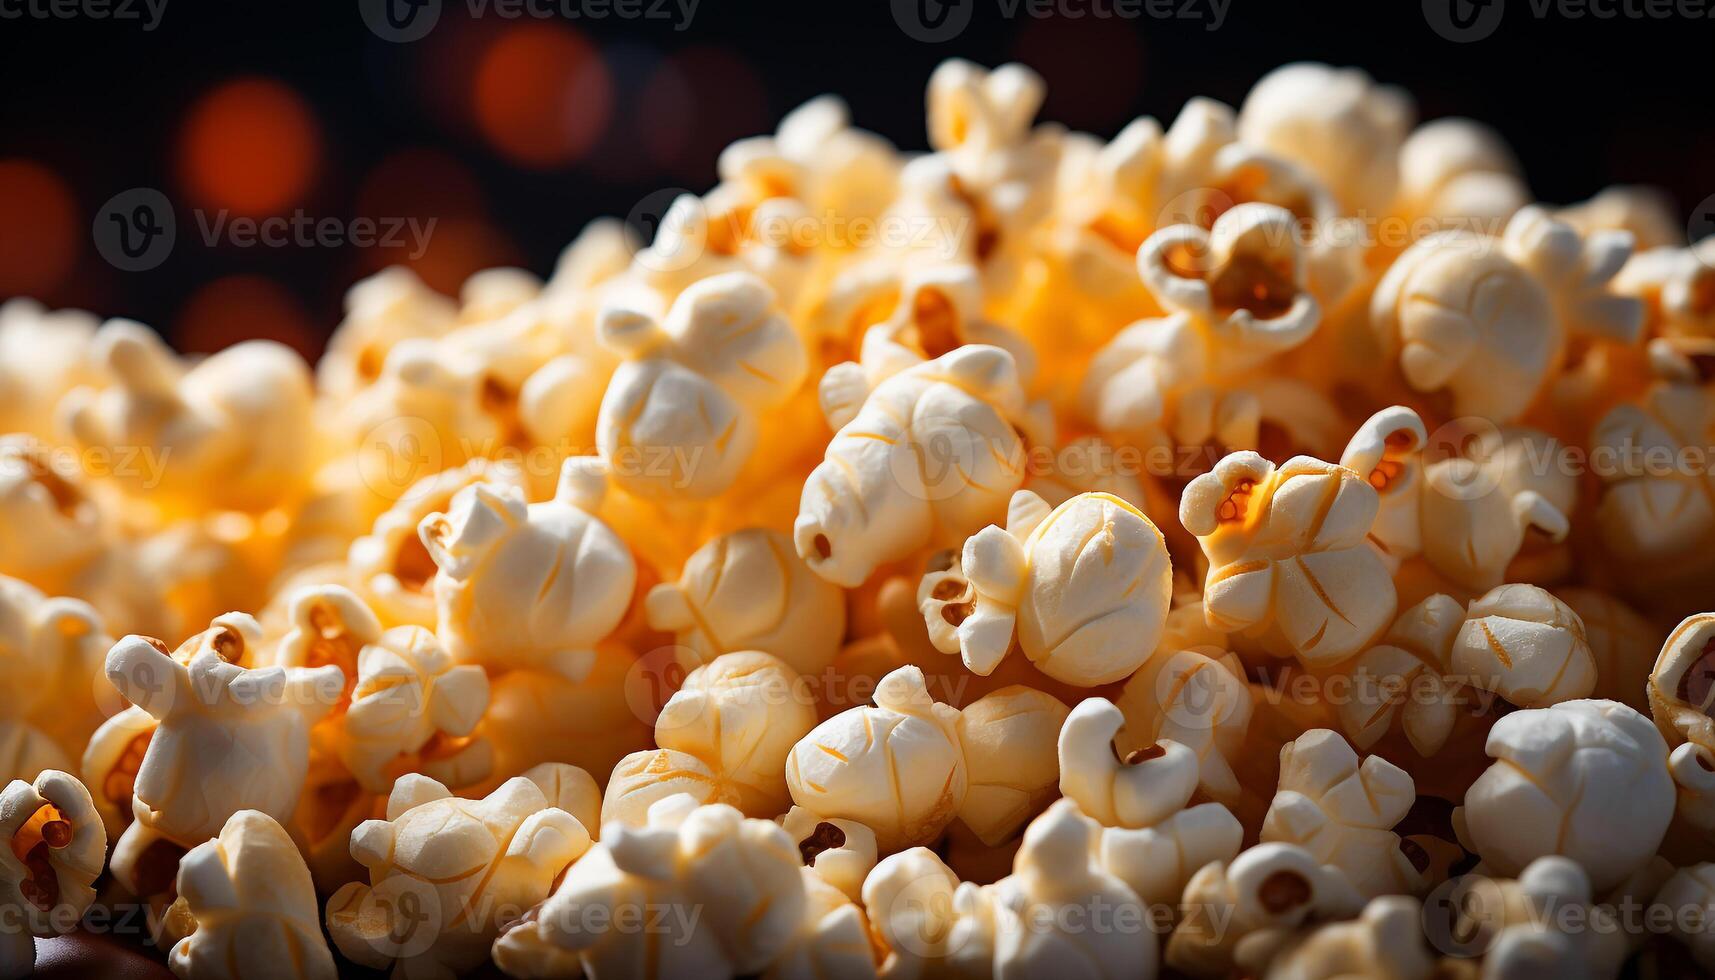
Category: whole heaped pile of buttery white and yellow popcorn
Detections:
[{"x1": 0, "y1": 62, "x2": 1715, "y2": 980}]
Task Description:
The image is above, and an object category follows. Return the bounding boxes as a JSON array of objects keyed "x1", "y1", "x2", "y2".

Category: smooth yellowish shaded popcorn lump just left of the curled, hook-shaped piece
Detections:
[{"x1": 959, "y1": 685, "x2": 1068, "y2": 846}]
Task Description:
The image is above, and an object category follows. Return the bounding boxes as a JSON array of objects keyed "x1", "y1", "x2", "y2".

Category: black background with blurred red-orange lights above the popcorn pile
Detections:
[{"x1": 0, "y1": 0, "x2": 1715, "y2": 354}]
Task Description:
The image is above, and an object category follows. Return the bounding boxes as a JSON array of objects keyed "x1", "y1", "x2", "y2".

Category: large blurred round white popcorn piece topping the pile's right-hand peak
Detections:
[{"x1": 1238, "y1": 62, "x2": 1417, "y2": 215}]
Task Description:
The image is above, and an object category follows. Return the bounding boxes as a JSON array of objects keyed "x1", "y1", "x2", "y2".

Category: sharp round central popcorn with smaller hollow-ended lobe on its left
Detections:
[{"x1": 918, "y1": 491, "x2": 1173, "y2": 687}]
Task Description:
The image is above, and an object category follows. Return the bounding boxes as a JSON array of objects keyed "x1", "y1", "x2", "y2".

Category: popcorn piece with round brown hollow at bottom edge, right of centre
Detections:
[{"x1": 1163, "y1": 843, "x2": 1363, "y2": 980}]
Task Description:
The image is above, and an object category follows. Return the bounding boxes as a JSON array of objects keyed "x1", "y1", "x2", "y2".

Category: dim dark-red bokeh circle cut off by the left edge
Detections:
[{"x1": 0, "y1": 160, "x2": 84, "y2": 297}]
